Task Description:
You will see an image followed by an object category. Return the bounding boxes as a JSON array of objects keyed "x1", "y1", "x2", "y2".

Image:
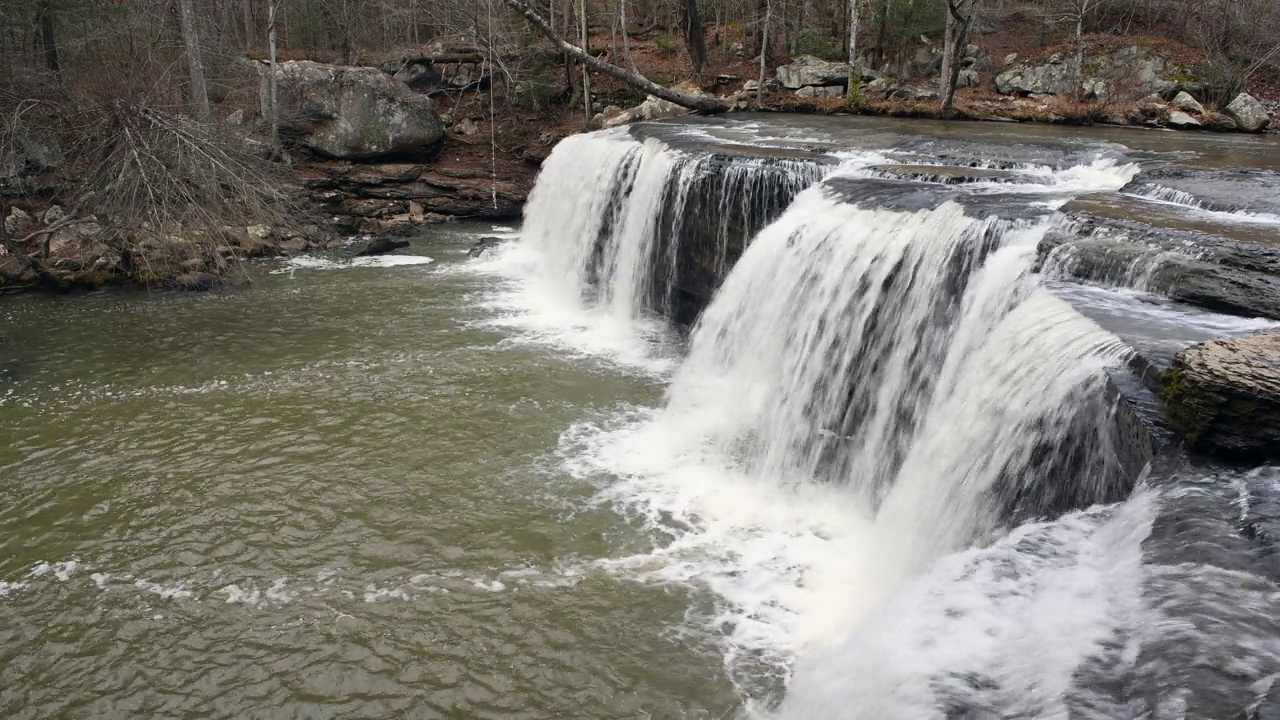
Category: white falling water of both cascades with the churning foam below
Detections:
[{"x1": 488, "y1": 127, "x2": 1182, "y2": 717}]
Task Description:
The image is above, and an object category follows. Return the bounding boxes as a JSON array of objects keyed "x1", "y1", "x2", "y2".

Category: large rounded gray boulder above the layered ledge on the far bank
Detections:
[{"x1": 262, "y1": 60, "x2": 444, "y2": 160}]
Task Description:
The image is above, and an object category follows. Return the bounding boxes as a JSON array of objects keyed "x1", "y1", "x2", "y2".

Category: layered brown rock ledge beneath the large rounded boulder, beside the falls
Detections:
[{"x1": 302, "y1": 163, "x2": 534, "y2": 233}]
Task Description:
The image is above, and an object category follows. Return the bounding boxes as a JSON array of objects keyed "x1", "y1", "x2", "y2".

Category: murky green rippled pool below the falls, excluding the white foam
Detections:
[{"x1": 0, "y1": 225, "x2": 737, "y2": 719}]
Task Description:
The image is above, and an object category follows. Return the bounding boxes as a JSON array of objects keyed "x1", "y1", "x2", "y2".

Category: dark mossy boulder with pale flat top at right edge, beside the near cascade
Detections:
[{"x1": 1164, "y1": 333, "x2": 1280, "y2": 461}]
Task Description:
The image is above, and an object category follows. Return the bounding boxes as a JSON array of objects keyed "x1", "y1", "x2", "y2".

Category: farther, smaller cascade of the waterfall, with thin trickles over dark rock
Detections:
[{"x1": 522, "y1": 129, "x2": 826, "y2": 324}]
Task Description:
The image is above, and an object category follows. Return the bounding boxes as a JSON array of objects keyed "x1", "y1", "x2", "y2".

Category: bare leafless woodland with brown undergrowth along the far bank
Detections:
[{"x1": 0, "y1": 0, "x2": 1280, "y2": 284}]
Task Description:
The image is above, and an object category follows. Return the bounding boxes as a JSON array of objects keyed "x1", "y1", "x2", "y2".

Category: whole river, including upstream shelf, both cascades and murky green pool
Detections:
[{"x1": 0, "y1": 118, "x2": 1280, "y2": 720}]
